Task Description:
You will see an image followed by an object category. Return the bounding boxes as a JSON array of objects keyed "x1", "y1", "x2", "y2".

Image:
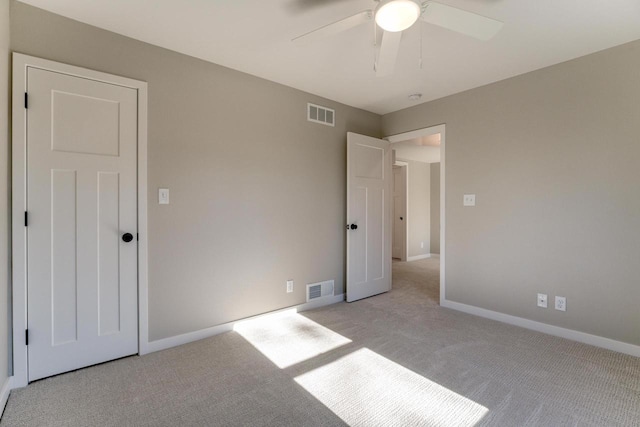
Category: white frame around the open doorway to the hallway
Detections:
[{"x1": 384, "y1": 123, "x2": 446, "y2": 305}]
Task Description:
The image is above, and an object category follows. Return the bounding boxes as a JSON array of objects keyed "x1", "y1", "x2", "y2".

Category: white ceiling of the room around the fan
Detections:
[{"x1": 21, "y1": 0, "x2": 640, "y2": 114}]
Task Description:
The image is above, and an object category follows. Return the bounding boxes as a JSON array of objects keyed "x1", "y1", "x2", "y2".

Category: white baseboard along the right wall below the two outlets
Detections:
[{"x1": 441, "y1": 300, "x2": 640, "y2": 357}]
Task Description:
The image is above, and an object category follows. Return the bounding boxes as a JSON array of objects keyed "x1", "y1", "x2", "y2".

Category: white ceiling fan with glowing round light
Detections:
[{"x1": 292, "y1": 0, "x2": 503, "y2": 77}]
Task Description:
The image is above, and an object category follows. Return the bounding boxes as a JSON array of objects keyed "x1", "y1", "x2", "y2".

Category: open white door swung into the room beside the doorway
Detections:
[{"x1": 347, "y1": 132, "x2": 392, "y2": 302}]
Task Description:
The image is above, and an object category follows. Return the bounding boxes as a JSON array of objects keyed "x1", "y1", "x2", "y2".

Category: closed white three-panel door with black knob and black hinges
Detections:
[{"x1": 27, "y1": 68, "x2": 138, "y2": 381}]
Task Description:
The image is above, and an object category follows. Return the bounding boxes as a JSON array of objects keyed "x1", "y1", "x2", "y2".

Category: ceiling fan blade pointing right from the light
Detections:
[{"x1": 422, "y1": 1, "x2": 504, "y2": 41}]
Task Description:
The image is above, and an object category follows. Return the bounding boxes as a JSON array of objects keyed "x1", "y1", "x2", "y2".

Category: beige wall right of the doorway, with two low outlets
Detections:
[{"x1": 383, "y1": 41, "x2": 640, "y2": 345}]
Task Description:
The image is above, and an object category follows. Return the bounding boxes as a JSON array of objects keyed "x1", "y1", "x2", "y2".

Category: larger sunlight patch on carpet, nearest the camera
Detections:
[{"x1": 295, "y1": 348, "x2": 488, "y2": 426}]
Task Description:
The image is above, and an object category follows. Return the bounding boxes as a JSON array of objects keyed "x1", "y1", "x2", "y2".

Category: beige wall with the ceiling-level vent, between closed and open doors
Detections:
[{"x1": 11, "y1": 2, "x2": 381, "y2": 340}]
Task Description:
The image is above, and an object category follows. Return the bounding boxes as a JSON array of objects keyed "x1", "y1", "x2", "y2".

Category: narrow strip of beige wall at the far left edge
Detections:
[{"x1": 0, "y1": 0, "x2": 12, "y2": 388}]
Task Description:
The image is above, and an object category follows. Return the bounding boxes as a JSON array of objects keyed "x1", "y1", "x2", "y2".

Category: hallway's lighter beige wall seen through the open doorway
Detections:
[{"x1": 398, "y1": 159, "x2": 431, "y2": 258}]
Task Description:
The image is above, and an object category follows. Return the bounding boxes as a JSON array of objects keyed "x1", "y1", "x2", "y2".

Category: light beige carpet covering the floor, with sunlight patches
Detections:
[{"x1": 0, "y1": 259, "x2": 640, "y2": 426}]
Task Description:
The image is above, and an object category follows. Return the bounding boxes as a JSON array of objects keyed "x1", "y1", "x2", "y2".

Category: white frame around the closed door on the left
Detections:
[{"x1": 11, "y1": 52, "x2": 149, "y2": 388}]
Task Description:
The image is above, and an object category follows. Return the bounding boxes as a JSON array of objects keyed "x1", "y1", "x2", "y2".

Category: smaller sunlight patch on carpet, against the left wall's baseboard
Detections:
[{"x1": 233, "y1": 312, "x2": 351, "y2": 369}]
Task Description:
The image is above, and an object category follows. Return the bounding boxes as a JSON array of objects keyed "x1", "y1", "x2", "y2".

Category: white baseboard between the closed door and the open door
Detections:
[{"x1": 145, "y1": 294, "x2": 344, "y2": 355}]
